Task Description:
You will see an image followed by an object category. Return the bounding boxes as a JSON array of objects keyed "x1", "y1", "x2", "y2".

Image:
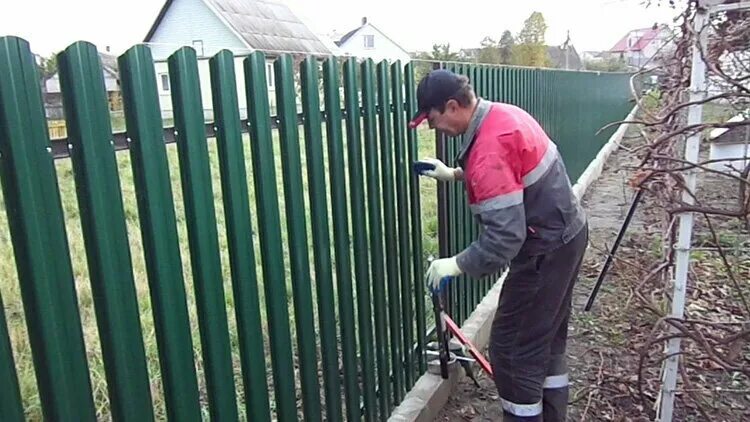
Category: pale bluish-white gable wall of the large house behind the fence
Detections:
[{"x1": 149, "y1": 0, "x2": 249, "y2": 60}]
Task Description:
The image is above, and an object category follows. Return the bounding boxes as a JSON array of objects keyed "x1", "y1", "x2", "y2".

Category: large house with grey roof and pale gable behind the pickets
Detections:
[{"x1": 144, "y1": 0, "x2": 332, "y2": 120}]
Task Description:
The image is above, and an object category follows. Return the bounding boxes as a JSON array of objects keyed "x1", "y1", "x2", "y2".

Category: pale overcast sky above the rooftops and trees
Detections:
[{"x1": 0, "y1": 0, "x2": 681, "y2": 55}]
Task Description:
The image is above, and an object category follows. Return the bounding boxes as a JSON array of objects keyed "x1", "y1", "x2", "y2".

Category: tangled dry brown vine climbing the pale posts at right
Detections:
[{"x1": 608, "y1": 0, "x2": 750, "y2": 420}]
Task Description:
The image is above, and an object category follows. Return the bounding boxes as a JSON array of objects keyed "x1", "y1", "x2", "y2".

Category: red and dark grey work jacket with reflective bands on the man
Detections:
[{"x1": 457, "y1": 99, "x2": 586, "y2": 277}]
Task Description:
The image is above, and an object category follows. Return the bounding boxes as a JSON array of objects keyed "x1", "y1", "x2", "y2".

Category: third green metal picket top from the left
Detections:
[{"x1": 118, "y1": 46, "x2": 201, "y2": 421}]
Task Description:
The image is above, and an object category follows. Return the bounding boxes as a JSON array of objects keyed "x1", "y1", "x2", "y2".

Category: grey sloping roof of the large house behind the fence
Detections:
[{"x1": 144, "y1": 0, "x2": 331, "y2": 54}]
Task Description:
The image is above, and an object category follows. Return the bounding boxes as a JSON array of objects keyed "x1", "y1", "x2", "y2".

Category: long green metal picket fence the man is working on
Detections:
[{"x1": 0, "y1": 37, "x2": 630, "y2": 421}]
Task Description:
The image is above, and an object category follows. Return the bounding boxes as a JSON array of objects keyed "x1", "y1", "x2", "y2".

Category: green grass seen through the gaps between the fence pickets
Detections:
[{"x1": 0, "y1": 118, "x2": 437, "y2": 420}]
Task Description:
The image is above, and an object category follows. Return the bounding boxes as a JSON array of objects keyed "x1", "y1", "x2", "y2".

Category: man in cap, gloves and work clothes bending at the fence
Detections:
[{"x1": 410, "y1": 70, "x2": 588, "y2": 421}]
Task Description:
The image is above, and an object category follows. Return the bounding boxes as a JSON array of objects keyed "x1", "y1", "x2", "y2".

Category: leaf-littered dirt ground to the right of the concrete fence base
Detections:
[{"x1": 436, "y1": 130, "x2": 750, "y2": 421}]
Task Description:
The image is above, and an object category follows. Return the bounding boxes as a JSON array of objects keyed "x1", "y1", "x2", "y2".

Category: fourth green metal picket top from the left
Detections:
[{"x1": 169, "y1": 47, "x2": 238, "y2": 421}]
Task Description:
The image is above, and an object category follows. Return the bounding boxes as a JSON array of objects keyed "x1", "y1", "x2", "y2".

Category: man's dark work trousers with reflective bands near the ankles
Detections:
[{"x1": 490, "y1": 226, "x2": 588, "y2": 422}]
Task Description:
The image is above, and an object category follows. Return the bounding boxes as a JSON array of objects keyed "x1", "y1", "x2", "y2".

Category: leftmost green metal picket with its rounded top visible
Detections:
[{"x1": 0, "y1": 37, "x2": 96, "y2": 421}]
